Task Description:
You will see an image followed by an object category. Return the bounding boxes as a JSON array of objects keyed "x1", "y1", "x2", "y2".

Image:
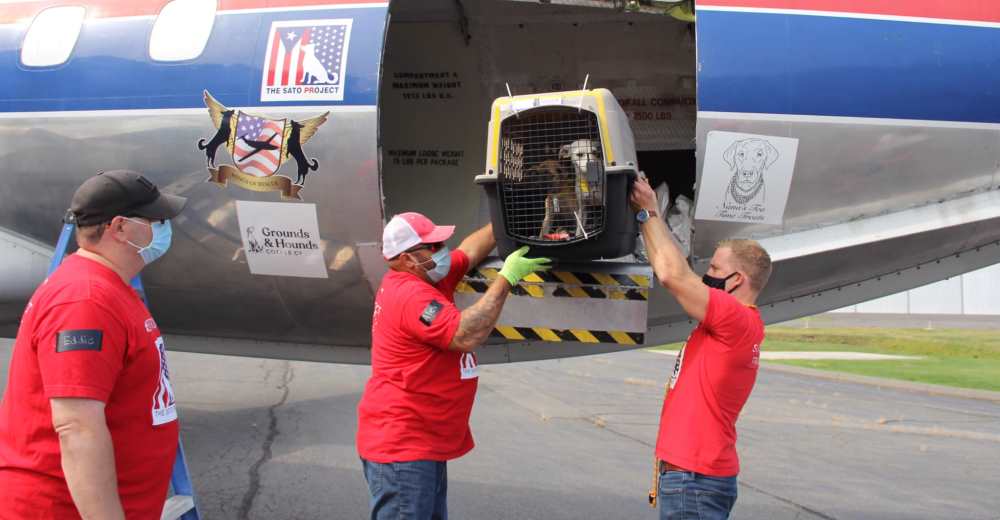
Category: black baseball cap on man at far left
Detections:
[{"x1": 66, "y1": 170, "x2": 187, "y2": 226}]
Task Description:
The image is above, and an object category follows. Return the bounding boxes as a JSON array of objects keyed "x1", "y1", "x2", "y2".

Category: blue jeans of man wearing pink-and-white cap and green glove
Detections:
[{"x1": 361, "y1": 459, "x2": 448, "y2": 520}]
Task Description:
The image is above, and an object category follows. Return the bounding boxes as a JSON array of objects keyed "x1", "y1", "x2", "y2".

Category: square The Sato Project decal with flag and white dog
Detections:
[{"x1": 260, "y1": 19, "x2": 351, "y2": 101}]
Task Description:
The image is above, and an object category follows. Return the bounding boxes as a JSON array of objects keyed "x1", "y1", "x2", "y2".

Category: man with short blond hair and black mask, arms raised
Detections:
[{"x1": 631, "y1": 178, "x2": 771, "y2": 520}]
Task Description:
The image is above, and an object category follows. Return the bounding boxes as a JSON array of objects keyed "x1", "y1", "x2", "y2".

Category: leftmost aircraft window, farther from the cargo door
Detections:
[{"x1": 21, "y1": 5, "x2": 87, "y2": 67}]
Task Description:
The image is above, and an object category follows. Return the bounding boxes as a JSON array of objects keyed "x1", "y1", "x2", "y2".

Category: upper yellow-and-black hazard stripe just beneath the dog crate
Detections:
[{"x1": 456, "y1": 269, "x2": 650, "y2": 301}]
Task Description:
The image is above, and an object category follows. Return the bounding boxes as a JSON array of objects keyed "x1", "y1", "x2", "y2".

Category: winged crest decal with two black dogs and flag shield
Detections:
[{"x1": 198, "y1": 90, "x2": 329, "y2": 200}]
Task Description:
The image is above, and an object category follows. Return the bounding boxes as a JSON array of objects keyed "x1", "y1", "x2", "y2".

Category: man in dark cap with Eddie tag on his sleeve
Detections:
[{"x1": 0, "y1": 170, "x2": 186, "y2": 520}]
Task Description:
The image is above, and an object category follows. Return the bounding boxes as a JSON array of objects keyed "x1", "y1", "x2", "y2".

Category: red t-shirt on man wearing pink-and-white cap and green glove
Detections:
[{"x1": 357, "y1": 250, "x2": 479, "y2": 463}]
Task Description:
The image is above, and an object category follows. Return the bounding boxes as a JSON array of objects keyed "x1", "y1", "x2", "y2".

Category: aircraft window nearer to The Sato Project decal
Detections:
[{"x1": 149, "y1": 0, "x2": 218, "y2": 61}]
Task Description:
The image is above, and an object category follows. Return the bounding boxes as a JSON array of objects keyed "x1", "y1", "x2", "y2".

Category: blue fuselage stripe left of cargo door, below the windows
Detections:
[{"x1": 0, "y1": 7, "x2": 386, "y2": 112}]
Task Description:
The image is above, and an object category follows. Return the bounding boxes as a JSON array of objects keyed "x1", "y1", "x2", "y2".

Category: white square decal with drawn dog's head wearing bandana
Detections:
[{"x1": 695, "y1": 131, "x2": 799, "y2": 224}]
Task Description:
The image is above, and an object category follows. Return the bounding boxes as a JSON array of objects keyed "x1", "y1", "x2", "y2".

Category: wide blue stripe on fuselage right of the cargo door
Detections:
[{"x1": 698, "y1": 11, "x2": 1000, "y2": 123}]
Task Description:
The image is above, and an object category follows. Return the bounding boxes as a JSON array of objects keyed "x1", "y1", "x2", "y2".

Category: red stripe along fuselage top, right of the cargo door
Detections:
[{"x1": 697, "y1": 0, "x2": 1000, "y2": 22}]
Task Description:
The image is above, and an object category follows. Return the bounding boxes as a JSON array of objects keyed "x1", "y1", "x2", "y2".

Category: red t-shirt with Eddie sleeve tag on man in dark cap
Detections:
[{"x1": 0, "y1": 255, "x2": 177, "y2": 520}]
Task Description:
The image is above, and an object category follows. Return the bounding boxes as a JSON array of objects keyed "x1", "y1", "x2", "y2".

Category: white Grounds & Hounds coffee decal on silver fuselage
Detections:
[{"x1": 236, "y1": 200, "x2": 328, "y2": 278}]
